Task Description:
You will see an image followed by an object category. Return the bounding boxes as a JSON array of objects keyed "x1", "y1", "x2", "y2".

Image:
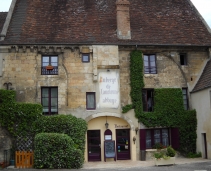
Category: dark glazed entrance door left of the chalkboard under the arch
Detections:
[{"x1": 87, "y1": 130, "x2": 101, "y2": 161}]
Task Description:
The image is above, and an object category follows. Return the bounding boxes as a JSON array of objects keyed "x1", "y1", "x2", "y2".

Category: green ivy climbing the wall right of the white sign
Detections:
[{"x1": 122, "y1": 50, "x2": 197, "y2": 154}]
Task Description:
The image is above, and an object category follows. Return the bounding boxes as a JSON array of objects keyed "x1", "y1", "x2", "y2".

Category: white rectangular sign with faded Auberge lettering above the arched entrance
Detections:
[{"x1": 98, "y1": 72, "x2": 119, "y2": 108}]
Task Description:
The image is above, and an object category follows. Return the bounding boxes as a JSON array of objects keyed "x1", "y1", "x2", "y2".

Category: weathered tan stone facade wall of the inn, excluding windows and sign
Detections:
[{"x1": 0, "y1": 45, "x2": 208, "y2": 161}]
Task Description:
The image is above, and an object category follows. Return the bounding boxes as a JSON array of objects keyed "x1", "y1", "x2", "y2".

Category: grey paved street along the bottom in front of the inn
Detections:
[{"x1": 4, "y1": 158, "x2": 211, "y2": 171}]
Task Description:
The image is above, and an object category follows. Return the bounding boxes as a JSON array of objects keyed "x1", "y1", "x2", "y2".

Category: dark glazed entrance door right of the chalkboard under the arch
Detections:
[{"x1": 116, "y1": 129, "x2": 130, "y2": 160}]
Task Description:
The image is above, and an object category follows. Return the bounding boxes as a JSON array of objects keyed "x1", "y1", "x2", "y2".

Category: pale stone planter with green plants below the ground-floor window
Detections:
[{"x1": 154, "y1": 146, "x2": 176, "y2": 166}]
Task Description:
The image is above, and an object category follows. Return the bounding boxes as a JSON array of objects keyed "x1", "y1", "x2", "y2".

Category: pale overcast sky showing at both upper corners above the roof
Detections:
[{"x1": 0, "y1": 0, "x2": 211, "y2": 28}]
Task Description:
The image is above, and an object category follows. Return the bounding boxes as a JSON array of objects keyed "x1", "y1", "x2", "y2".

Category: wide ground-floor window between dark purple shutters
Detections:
[{"x1": 146, "y1": 128, "x2": 169, "y2": 148}]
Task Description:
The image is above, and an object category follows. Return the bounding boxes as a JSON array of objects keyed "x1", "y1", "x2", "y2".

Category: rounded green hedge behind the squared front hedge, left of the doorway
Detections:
[{"x1": 33, "y1": 114, "x2": 87, "y2": 152}]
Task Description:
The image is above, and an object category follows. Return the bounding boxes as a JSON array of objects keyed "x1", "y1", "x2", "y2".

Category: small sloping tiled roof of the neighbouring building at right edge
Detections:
[{"x1": 192, "y1": 60, "x2": 211, "y2": 92}]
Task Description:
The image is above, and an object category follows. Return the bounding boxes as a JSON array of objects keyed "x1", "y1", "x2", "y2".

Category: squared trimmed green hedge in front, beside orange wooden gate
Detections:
[{"x1": 34, "y1": 133, "x2": 83, "y2": 169}]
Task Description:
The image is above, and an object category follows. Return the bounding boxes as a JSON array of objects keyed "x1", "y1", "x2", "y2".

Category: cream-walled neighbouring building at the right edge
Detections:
[{"x1": 191, "y1": 52, "x2": 211, "y2": 158}]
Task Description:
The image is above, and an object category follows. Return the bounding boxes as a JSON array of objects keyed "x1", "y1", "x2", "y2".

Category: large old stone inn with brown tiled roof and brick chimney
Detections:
[{"x1": 0, "y1": 0, "x2": 211, "y2": 161}]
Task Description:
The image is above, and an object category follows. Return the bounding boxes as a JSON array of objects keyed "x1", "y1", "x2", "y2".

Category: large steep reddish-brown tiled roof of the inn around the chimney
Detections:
[{"x1": 4, "y1": 0, "x2": 211, "y2": 46}]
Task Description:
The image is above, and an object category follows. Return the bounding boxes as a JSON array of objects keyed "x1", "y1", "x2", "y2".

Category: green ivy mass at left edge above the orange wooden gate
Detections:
[{"x1": 0, "y1": 90, "x2": 42, "y2": 137}]
